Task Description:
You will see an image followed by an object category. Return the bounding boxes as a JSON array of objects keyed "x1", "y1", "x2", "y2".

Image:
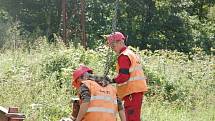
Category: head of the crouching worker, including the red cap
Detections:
[{"x1": 72, "y1": 65, "x2": 93, "y2": 88}]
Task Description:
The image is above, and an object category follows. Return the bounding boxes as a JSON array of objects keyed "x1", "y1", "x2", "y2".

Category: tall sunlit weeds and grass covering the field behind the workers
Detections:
[{"x1": 0, "y1": 41, "x2": 215, "y2": 121}]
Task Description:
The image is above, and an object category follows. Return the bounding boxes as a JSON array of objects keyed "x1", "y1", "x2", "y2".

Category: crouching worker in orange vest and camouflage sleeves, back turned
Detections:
[{"x1": 72, "y1": 65, "x2": 126, "y2": 121}]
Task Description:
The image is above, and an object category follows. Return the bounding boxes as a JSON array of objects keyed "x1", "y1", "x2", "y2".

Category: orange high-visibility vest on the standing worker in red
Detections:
[{"x1": 116, "y1": 48, "x2": 148, "y2": 99}]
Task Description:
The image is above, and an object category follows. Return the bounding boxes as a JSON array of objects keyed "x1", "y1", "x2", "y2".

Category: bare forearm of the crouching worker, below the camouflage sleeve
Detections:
[{"x1": 75, "y1": 102, "x2": 89, "y2": 121}]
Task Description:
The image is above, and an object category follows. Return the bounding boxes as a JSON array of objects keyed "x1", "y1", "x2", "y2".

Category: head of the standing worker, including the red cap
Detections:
[{"x1": 105, "y1": 32, "x2": 125, "y2": 53}]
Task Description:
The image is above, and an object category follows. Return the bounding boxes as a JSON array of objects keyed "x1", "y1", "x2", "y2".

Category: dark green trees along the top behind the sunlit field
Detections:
[{"x1": 0, "y1": 0, "x2": 215, "y2": 54}]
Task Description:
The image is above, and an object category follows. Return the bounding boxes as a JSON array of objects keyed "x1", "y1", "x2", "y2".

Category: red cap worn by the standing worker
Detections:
[{"x1": 107, "y1": 32, "x2": 125, "y2": 44}]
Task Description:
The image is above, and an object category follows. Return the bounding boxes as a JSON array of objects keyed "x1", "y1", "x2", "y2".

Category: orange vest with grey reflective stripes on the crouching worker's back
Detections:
[{"x1": 82, "y1": 80, "x2": 117, "y2": 121}]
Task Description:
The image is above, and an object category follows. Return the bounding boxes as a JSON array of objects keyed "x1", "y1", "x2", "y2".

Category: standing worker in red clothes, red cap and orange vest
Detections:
[{"x1": 105, "y1": 32, "x2": 148, "y2": 121}]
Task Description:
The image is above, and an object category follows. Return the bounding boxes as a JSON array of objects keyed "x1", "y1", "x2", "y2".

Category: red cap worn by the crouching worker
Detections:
[{"x1": 72, "y1": 65, "x2": 92, "y2": 88}]
